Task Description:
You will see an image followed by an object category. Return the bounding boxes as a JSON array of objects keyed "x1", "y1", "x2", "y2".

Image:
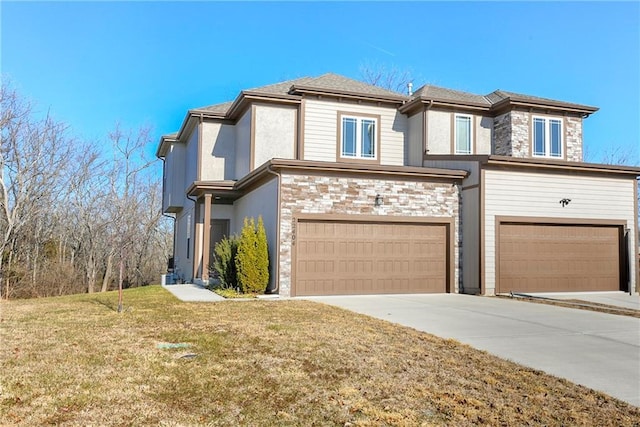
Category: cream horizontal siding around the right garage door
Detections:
[{"x1": 484, "y1": 170, "x2": 638, "y2": 295}]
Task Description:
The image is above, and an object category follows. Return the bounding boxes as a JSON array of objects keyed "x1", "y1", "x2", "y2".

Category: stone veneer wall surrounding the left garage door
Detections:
[{"x1": 279, "y1": 173, "x2": 462, "y2": 296}]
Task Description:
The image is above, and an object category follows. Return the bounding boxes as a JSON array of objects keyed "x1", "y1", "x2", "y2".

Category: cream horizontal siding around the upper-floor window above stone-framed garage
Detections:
[{"x1": 304, "y1": 99, "x2": 407, "y2": 166}]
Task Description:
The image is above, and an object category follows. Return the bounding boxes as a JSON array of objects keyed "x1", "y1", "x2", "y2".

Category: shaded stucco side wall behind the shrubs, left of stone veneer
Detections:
[{"x1": 230, "y1": 178, "x2": 278, "y2": 286}]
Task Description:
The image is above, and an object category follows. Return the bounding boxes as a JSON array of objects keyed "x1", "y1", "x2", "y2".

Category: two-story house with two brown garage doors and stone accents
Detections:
[{"x1": 157, "y1": 74, "x2": 640, "y2": 296}]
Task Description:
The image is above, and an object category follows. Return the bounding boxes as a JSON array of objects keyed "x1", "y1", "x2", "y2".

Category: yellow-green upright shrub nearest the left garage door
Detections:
[{"x1": 236, "y1": 217, "x2": 269, "y2": 293}]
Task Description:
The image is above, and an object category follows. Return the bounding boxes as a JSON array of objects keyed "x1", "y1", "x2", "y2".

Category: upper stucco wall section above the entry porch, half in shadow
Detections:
[{"x1": 200, "y1": 122, "x2": 236, "y2": 181}]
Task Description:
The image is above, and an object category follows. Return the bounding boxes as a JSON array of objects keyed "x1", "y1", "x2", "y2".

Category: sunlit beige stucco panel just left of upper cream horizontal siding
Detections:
[{"x1": 253, "y1": 105, "x2": 298, "y2": 168}]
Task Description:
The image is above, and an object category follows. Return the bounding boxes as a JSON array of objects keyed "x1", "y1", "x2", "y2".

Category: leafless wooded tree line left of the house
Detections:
[{"x1": 0, "y1": 81, "x2": 172, "y2": 299}]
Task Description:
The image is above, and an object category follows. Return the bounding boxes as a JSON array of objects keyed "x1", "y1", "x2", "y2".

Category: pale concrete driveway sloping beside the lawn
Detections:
[{"x1": 304, "y1": 294, "x2": 640, "y2": 406}]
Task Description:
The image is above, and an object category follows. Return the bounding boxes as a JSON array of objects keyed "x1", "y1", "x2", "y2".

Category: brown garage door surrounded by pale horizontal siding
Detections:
[{"x1": 497, "y1": 223, "x2": 620, "y2": 293}]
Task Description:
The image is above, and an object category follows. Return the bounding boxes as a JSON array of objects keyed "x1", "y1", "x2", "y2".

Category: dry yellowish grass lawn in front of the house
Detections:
[{"x1": 0, "y1": 286, "x2": 640, "y2": 426}]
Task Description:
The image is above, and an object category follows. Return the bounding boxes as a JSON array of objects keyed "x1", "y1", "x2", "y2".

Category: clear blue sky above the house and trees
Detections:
[{"x1": 0, "y1": 1, "x2": 640, "y2": 163}]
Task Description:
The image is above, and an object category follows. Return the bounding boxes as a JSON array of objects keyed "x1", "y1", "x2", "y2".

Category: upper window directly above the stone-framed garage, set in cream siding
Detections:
[{"x1": 340, "y1": 114, "x2": 378, "y2": 160}]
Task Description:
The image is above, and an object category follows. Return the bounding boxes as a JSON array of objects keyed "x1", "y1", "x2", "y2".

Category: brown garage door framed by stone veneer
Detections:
[{"x1": 294, "y1": 220, "x2": 448, "y2": 295}]
